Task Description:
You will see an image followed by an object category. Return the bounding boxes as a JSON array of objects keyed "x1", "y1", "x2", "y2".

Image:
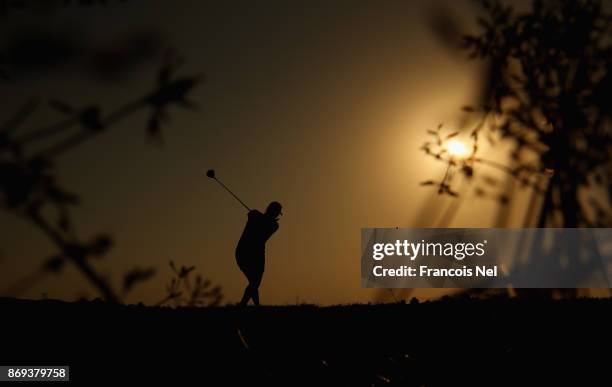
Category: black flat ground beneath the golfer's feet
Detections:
[{"x1": 0, "y1": 298, "x2": 612, "y2": 386}]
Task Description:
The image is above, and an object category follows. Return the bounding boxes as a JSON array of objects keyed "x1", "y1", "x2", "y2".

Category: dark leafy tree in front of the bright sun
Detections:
[{"x1": 422, "y1": 0, "x2": 612, "y2": 227}]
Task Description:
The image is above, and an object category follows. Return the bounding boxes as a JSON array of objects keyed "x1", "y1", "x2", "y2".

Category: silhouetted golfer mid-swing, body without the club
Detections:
[{"x1": 236, "y1": 202, "x2": 283, "y2": 306}]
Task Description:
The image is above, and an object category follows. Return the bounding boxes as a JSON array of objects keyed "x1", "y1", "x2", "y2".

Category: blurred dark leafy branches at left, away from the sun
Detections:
[{"x1": 0, "y1": 53, "x2": 199, "y2": 302}]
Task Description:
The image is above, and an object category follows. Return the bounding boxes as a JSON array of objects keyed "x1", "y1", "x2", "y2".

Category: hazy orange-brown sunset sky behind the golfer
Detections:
[{"x1": 0, "y1": 1, "x2": 532, "y2": 304}]
